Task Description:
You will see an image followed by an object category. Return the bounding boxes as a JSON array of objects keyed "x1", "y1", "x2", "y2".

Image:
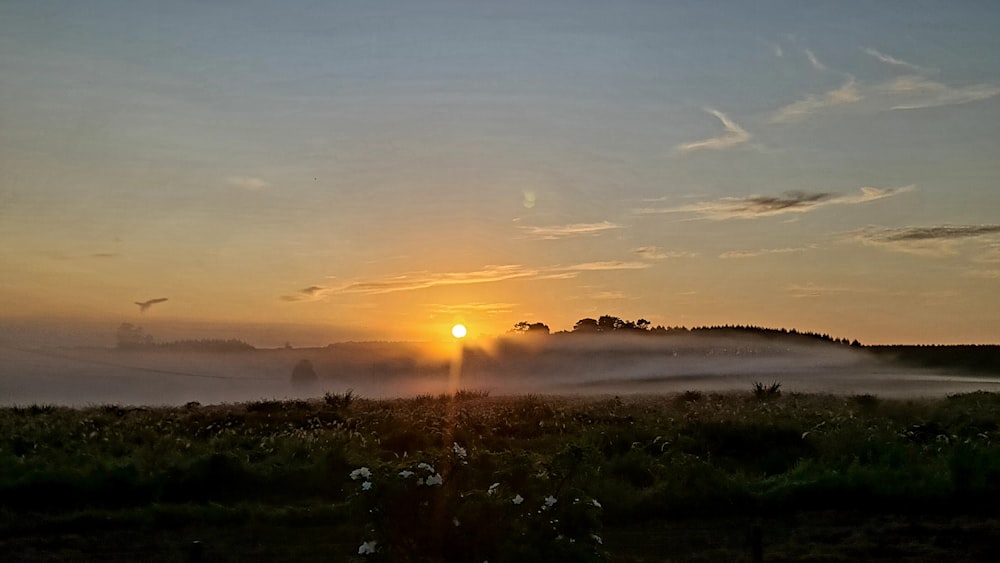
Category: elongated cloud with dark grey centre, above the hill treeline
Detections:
[{"x1": 635, "y1": 185, "x2": 915, "y2": 220}]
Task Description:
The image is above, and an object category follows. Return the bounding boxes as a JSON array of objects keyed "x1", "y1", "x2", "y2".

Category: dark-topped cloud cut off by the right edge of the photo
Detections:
[{"x1": 848, "y1": 225, "x2": 1000, "y2": 257}]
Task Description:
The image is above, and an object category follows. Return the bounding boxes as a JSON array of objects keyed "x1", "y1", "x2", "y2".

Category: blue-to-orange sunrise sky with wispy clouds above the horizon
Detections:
[{"x1": 0, "y1": 0, "x2": 1000, "y2": 344}]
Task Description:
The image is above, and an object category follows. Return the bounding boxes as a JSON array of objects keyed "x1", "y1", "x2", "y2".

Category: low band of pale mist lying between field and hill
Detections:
[{"x1": 0, "y1": 335, "x2": 1000, "y2": 406}]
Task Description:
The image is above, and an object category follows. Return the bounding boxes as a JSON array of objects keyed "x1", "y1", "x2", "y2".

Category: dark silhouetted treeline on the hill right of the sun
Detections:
[{"x1": 508, "y1": 315, "x2": 861, "y2": 347}]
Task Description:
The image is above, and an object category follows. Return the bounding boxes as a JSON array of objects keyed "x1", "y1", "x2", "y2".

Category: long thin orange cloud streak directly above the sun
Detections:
[{"x1": 281, "y1": 260, "x2": 650, "y2": 302}]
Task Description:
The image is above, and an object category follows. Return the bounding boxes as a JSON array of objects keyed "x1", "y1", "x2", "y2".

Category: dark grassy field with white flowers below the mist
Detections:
[{"x1": 0, "y1": 385, "x2": 1000, "y2": 562}]
